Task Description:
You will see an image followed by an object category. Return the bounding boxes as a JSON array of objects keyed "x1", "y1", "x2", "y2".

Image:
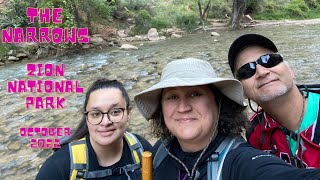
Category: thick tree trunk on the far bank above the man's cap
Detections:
[{"x1": 230, "y1": 0, "x2": 246, "y2": 29}]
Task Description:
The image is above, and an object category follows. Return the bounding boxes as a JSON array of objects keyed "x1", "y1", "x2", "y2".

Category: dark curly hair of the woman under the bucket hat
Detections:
[{"x1": 151, "y1": 86, "x2": 248, "y2": 139}]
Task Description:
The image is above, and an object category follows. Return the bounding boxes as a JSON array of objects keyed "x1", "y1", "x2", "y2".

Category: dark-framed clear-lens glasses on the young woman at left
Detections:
[{"x1": 84, "y1": 108, "x2": 126, "y2": 125}]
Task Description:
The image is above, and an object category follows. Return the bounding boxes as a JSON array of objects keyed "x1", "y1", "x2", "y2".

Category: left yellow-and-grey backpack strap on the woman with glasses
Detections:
[{"x1": 69, "y1": 137, "x2": 89, "y2": 180}]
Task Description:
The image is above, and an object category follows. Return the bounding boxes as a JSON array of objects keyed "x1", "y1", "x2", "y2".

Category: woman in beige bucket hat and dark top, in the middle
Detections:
[{"x1": 135, "y1": 58, "x2": 320, "y2": 180}]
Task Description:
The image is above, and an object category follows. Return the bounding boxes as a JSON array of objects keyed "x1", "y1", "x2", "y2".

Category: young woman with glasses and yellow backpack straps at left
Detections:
[{"x1": 36, "y1": 79, "x2": 152, "y2": 180}]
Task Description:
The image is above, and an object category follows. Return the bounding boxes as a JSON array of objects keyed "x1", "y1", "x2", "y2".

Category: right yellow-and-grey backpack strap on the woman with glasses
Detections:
[{"x1": 124, "y1": 132, "x2": 144, "y2": 164}]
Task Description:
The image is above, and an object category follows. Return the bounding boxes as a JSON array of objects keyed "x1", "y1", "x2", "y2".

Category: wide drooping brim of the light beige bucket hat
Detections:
[{"x1": 134, "y1": 78, "x2": 245, "y2": 120}]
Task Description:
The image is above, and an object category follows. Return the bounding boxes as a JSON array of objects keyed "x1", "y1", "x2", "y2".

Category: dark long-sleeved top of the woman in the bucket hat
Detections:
[{"x1": 153, "y1": 136, "x2": 320, "y2": 180}]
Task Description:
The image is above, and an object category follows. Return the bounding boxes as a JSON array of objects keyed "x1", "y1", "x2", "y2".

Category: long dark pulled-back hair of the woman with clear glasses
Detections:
[{"x1": 61, "y1": 78, "x2": 130, "y2": 146}]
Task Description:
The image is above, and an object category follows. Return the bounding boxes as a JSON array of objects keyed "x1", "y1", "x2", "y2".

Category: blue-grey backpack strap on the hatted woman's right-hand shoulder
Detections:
[{"x1": 207, "y1": 137, "x2": 245, "y2": 180}]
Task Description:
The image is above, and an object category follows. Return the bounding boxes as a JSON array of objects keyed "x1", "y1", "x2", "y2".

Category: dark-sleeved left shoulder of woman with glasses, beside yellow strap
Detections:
[{"x1": 36, "y1": 145, "x2": 70, "y2": 180}]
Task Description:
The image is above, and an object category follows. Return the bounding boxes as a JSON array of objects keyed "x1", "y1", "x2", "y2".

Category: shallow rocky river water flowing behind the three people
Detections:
[{"x1": 0, "y1": 25, "x2": 320, "y2": 179}]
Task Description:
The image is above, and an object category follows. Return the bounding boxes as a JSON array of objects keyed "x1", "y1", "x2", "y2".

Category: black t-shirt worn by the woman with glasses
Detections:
[{"x1": 36, "y1": 135, "x2": 152, "y2": 180}]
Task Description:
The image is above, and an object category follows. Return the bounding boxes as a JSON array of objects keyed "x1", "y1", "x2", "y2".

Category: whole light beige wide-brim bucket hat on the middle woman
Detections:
[{"x1": 134, "y1": 58, "x2": 244, "y2": 120}]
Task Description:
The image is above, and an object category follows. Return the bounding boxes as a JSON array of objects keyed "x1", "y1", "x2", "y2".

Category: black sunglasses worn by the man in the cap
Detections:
[{"x1": 236, "y1": 53, "x2": 283, "y2": 80}]
